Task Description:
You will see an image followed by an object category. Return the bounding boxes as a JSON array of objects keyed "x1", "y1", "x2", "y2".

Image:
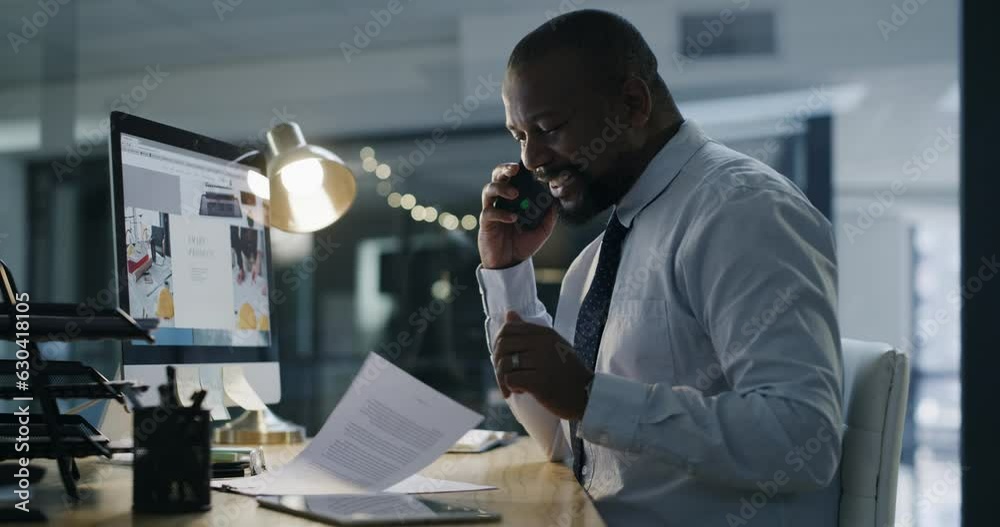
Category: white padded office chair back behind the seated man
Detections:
[{"x1": 840, "y1": 339, "x2": 910, "y2": 527}]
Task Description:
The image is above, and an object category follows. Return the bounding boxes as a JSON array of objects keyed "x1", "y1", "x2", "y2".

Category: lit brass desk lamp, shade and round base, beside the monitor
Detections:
[{"x1": 214, "y1": 123, "x2": 357, "y2": 444}]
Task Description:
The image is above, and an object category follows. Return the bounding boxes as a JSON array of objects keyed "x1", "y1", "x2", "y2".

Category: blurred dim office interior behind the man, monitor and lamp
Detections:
[{"x1": 0, "y1": 0, "x2": 964, "y2": 527}]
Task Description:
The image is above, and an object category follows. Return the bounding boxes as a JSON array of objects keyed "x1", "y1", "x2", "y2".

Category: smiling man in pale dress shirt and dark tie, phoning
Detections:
[{"x1": 477, "y1": 10, "x2": 843, "y2": 527}]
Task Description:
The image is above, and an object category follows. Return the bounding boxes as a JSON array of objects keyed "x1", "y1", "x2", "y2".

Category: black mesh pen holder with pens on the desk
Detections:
[{"x1": 132, "y1": 366, "x2": 212, "y2": 513}]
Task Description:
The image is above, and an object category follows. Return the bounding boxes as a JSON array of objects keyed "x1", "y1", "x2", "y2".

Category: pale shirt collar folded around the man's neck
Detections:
[{"x1": 615, "y1": 120, "x2": 711, "y2": 228}]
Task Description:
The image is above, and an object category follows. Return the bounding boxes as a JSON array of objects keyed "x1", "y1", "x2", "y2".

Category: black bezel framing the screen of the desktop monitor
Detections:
[{"x1": 109, "y1": 111, "x2": 278, "y2": 366}]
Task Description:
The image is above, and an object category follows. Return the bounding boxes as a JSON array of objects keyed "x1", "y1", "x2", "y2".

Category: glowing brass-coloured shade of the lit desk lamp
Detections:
[{"x1": 267, "y1": 123, "x2": 358, "y2": 232}]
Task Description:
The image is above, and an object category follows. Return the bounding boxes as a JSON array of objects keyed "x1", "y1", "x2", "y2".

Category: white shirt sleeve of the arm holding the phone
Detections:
[{"x1": 476, "y1": 258, "x2": 569, "y2": 461}]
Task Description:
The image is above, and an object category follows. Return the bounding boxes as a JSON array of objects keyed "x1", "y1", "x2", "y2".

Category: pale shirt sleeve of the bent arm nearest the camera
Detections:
[{"x1": 578, "y1": 187, "x2": 843, "y2": 492}]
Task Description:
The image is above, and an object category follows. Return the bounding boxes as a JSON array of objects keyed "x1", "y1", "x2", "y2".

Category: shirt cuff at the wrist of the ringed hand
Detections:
[{"x1": 577, "y1": 373, "x2": 650, "y2": 452}]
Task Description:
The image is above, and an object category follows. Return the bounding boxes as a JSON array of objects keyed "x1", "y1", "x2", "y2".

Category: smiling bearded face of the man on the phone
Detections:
[{"x1": 503, "y1": 52, "x2": 627, "y2": 224}]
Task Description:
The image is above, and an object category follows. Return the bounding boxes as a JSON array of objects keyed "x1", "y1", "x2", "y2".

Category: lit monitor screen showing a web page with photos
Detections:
[{"x1": 116, "y1": 133, "x2": 272, "y2": 356}]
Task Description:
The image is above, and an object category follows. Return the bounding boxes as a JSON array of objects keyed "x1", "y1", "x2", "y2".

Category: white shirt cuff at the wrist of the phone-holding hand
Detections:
[{"x1": 476, "y1": 258, "x2": 538, "y2": 320}]
